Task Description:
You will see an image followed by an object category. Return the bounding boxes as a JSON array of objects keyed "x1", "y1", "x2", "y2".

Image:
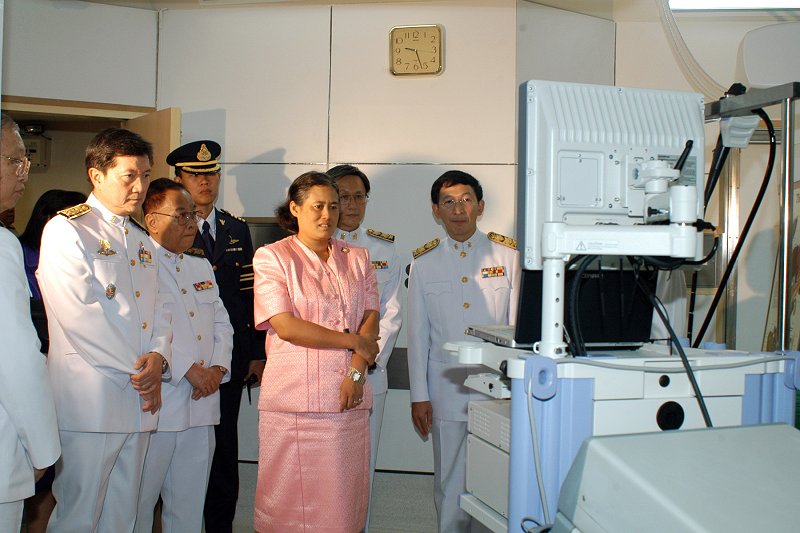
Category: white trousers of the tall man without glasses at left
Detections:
[{"x1": 47, "y1": 431, "x2": 150, "y2": 533}]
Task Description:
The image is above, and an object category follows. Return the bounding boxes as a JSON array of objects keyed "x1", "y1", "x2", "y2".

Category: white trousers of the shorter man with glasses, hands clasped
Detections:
[{"x1": 134, "y1": 426, "x2": 215, "y2": 533}]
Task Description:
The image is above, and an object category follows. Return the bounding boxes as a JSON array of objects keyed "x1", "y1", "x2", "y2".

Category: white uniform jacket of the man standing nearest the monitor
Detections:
[{"x1": 408, "y1": 231, "x2": 521, "y2": 421}]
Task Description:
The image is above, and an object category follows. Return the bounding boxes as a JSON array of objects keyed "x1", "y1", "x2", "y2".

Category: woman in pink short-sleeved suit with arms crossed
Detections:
[{"x1": 253, "y1": 172, "x2": 379, "y2": 533}]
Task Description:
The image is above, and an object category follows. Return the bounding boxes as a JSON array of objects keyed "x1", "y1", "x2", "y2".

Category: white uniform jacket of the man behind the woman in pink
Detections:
[{"x1": 338, "y1": 226, "x2": 403, "y2": 395}]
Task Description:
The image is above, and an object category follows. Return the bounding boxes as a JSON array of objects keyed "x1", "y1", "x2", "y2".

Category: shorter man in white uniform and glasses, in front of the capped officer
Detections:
[{"x1": 135, "y1": 178, "x2": 233, "y2": 533}]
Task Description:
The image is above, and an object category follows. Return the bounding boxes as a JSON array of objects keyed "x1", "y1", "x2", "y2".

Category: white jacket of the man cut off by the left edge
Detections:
[{"x1": 0, "y1": 227, "x2": 61, "y2": 502}]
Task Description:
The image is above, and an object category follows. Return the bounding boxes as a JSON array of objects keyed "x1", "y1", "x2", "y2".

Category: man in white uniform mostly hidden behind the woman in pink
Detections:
[{"x1": 327, "y1": 165, "x2": 403, "y2": 528}]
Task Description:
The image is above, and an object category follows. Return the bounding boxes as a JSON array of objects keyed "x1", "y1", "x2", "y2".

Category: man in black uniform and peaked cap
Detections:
[{"x1": 167, "y1": 140, "x2": 266, "y2": 533}]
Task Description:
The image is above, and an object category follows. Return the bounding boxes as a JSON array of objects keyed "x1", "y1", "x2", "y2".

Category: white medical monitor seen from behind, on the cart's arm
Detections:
[{"x1": 517, "y1": 80, "x2": 704, "y2": 270}]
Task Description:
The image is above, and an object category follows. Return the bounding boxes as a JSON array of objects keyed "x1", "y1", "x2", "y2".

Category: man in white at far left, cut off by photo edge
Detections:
[{"x1": 0, "y1": 113, "x2": 61, "y2": 531}]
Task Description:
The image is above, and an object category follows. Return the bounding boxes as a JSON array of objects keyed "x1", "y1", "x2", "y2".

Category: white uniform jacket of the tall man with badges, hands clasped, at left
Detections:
[{"x1": 36, "y1": 195, "x2": 172, "y2": 433}]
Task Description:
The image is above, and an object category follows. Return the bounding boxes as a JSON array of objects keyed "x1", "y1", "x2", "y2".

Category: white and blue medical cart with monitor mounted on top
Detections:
[{"x1": 454, "y1": 81, "x2": 800, "y2": 531}]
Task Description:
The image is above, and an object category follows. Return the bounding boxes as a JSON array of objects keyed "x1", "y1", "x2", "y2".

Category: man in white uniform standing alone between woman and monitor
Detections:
[{"x1": 408, "y1": 170, "x2": 521, "y2": 533}]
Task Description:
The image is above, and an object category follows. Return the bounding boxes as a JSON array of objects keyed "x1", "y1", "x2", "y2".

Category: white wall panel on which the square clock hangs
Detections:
[{"x1": 330, "y1": 0, "x2": 516, "y2": 163}]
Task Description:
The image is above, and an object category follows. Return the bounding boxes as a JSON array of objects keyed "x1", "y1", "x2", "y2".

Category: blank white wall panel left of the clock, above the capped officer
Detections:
[{"x1": 158, "y1": 6, "x2": 330, "y2": 163}]
